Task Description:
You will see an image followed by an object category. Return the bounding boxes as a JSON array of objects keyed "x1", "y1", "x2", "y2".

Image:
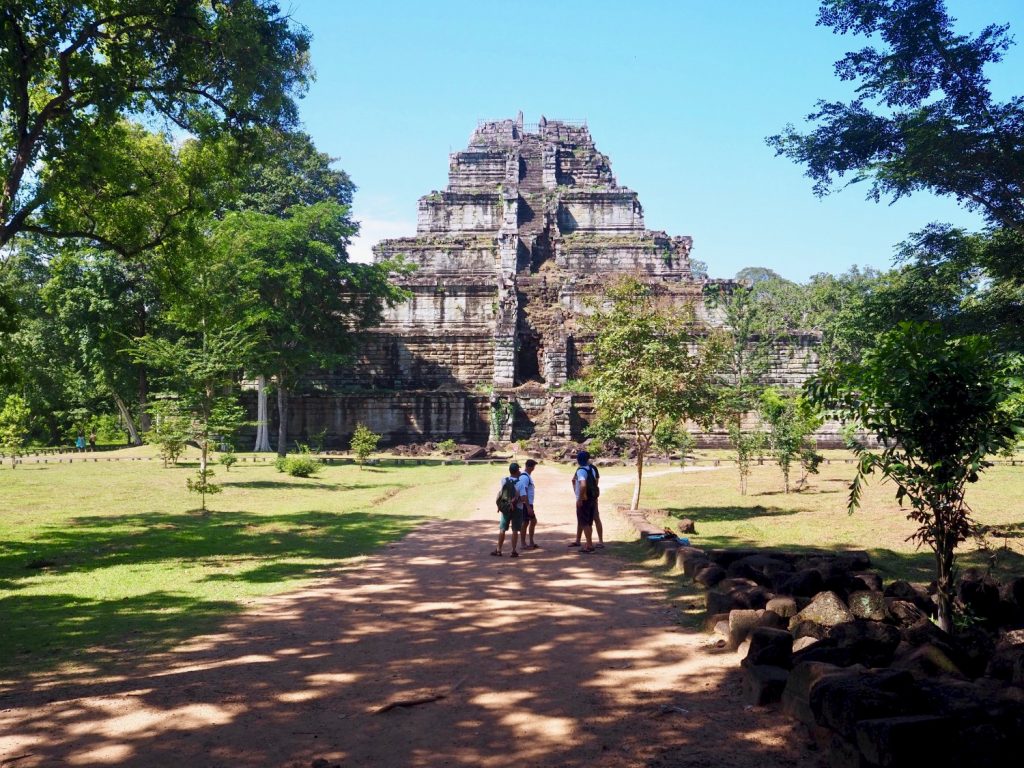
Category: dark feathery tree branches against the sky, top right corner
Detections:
[{"x1": 768, "y1": 0, "x2": 1024, "y2": 347}]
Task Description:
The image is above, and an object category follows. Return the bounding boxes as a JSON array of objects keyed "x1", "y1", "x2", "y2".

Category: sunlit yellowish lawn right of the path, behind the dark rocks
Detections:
[{"x1": 601, "y1": 452, "x2": 1024, "y2": 582}]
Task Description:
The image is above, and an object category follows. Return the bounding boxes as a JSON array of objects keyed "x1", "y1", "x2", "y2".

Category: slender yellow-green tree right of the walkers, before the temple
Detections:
[{"x1": 584, "y1": 279, "x2": 724, "y2": 509}]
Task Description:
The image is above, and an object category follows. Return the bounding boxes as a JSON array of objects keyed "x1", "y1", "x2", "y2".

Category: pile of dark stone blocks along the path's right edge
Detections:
[{"x1": 634, "y1": 521, "x2": 1024, "y2": 768}]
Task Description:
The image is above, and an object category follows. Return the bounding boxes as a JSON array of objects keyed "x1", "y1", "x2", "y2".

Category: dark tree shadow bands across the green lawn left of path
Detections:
[{"x1": 0, "y1": 510, "x2": 424, "y2": 670}]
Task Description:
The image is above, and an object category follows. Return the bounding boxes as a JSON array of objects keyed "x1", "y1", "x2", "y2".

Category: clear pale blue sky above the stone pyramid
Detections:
[{"x1": 289, "y1": 0, "x2": 1024, "y2": 281}]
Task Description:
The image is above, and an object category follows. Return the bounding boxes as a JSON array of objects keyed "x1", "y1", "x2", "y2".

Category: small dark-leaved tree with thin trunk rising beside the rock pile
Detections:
[{"x1": 806, "y1": 323, "x2": 1024, "y2": 632}]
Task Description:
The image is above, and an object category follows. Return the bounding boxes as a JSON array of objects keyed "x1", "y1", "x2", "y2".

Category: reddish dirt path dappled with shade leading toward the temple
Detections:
[{"x1": 0, "y1": 467, "x2": 815, "y2": 768}]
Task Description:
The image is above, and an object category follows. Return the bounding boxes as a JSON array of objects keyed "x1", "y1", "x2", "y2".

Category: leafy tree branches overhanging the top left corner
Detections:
[{"x1": 0, "y1": 0, "x2": 309, "y2": 249}]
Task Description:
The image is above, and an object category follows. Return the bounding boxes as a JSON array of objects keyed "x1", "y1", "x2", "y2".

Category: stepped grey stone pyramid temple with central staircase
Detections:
[{"x1": 278, "y1": 113, "x2": 815, "y2": 444}]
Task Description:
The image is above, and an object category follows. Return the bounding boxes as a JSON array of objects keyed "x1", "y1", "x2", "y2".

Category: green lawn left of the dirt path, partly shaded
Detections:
[{"x1": 0, "y1": 449, "x2": 501, "y2": 680}]
